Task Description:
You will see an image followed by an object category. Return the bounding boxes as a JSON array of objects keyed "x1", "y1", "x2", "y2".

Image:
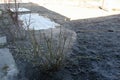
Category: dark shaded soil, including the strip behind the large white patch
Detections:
[{"x1": 0, "y1": 3, "x2": 120, "y2": 80}]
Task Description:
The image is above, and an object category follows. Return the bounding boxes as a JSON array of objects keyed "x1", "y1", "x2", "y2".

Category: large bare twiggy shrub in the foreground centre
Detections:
[{"x1": 26, "y1": 28, "x2": 76, "y2": 71}]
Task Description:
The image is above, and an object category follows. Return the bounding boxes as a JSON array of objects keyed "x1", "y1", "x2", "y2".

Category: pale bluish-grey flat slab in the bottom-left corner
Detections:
[{"x1": 0, "y1": 48, "x2": 19, "y2": 80}]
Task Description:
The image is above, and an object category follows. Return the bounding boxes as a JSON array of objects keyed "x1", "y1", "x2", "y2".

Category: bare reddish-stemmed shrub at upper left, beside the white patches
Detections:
[{"x1": 4, "y1": 0, "x2": 26, "y2": 42}]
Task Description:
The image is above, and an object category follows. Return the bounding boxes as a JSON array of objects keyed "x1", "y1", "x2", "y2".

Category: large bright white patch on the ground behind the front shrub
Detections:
[{"x1": 19, "y1": 13, "x2": 60, "y2": 30}]
